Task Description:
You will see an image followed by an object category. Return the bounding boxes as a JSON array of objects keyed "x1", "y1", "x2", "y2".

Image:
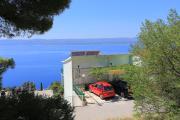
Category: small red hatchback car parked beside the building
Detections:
[{"x1": 89, "y1": 81, "x2": 115, "y2": 99}]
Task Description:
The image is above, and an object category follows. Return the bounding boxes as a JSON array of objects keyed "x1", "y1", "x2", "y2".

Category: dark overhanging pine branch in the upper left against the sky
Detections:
[{"x1": 0, "y1": 0, "x2": 71, "y2": 37}]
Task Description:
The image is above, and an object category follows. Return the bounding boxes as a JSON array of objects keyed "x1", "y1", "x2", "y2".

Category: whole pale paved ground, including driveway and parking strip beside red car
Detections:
[{"x1": 75, "y1": 87, "x2": 134, "y2": 120}]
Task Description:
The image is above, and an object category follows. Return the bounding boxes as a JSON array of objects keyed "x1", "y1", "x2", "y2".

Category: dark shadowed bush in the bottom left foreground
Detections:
[{"x1": 0, "y1": 92, "x2": 74, "y2": 120}]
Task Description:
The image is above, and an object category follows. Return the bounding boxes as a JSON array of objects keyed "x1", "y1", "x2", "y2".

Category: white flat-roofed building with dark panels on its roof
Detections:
[{"x1": 63, "y1": 51, "x2": 132, "y2": 105}]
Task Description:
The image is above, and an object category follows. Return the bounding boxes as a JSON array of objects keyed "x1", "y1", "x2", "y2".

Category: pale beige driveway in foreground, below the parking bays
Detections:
[{"x1": 75, "y1": 99, "x2": 134, "y2": 120}]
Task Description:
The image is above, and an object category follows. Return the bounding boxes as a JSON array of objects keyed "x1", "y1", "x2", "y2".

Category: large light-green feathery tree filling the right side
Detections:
[{"x1": 125, "y1": 10, "x2": 180, "y2": 120}]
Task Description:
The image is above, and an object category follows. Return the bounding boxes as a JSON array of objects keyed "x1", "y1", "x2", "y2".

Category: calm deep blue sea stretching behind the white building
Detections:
[{"x1": 0, "y1": 38, "x2": 136, "y2": 88}]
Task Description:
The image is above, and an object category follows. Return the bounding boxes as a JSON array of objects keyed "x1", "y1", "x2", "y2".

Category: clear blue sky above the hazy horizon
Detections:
[{"x1": 32, "y1": 0, "x2": 180, "y2": 39}]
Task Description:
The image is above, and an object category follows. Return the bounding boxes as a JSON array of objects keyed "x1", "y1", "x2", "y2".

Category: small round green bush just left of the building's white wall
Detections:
[{"x1": 49, "y1": 81, "x2": 64, "y2": 95}]
